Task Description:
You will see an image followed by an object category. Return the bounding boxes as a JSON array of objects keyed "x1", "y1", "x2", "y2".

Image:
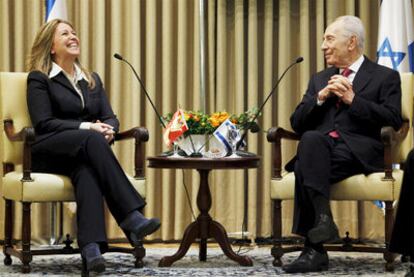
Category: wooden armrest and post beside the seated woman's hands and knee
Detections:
[{"x1": 115, "y1": 127, "x2": 149, "y2": 178}]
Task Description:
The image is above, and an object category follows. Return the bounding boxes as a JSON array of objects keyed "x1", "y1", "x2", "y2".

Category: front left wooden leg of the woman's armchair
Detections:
[{"x1": 22, "y1": 202, "x2": 32, "y2": 273}]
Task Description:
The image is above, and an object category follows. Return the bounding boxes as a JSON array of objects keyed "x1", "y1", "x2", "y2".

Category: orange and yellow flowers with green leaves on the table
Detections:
[{"x1": 163, "y1": 108, "x2": 259, "y2": 137}]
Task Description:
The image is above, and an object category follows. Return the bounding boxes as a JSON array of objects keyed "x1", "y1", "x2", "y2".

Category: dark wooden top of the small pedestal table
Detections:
[{"x1": 147, "y1": 156, "x2": 260, "y2": 169}]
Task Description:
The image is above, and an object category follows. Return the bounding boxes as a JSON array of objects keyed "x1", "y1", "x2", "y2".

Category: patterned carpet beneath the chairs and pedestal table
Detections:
[{"x1": 0, "y1": 246, "x2": 408, "y2": 277}]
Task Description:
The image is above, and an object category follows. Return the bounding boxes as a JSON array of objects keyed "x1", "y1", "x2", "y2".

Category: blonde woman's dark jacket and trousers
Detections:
[{"x1": 27, "y1": 71, "x2": 145, "y2": 250}]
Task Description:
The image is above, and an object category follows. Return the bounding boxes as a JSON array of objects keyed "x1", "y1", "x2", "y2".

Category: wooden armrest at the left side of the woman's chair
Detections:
[{"x1": 3, "y1": 119, "x2": 35, "y2": 182}]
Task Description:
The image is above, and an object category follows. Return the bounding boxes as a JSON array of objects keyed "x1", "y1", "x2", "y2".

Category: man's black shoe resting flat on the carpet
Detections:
[{"x1": 282, "y1": 247, "x2": 329, "y2": 273}]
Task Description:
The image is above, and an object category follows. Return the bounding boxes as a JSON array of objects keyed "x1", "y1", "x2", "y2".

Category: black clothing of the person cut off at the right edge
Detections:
[{"x1": 390, "y1": 150, "x2": 414, "y2": 277}]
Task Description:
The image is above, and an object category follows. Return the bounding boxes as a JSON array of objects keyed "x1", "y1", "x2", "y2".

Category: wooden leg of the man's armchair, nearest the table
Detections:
[{"x1": 271, "y1": 200, "x2": 284, "y2": 266}]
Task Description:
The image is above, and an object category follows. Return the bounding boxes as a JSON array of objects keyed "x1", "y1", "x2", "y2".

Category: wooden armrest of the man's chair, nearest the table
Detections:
[{"x1": 267, "y1": 127, "x2": 300, "y2": 179}]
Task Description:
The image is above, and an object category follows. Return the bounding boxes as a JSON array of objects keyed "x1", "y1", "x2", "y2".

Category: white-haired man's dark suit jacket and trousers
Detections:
[{"x1": 290, "y1": 57, "x2": 402, "y2": 236}]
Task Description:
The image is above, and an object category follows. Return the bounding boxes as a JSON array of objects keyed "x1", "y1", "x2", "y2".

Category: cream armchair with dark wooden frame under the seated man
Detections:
[{"x1": 267, "y1": 73, "x2": 414, "y2": 271}]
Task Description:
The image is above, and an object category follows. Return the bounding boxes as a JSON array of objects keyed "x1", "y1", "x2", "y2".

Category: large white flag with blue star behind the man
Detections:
[{"x1": 377, "y1": 0, "x2": 414, "y2": 72}]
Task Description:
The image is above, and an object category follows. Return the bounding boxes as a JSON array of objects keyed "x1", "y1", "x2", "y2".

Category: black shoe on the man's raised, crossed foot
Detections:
[{"x1": 308, "y1": 214, "x2": 340, "y2": 244}]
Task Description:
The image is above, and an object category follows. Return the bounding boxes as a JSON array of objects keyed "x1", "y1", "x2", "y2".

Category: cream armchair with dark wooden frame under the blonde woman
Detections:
[{"x1": 0, "y1": 72, "x2": 148, "y2": 273}]
